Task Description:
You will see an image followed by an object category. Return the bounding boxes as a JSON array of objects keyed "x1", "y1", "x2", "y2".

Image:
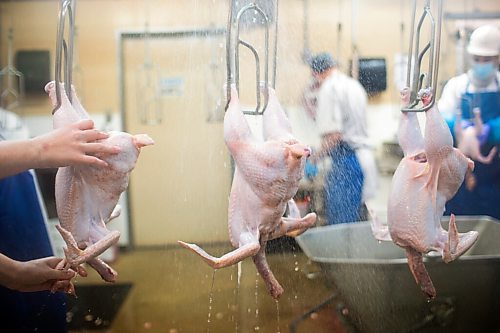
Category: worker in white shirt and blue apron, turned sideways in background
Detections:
[{"x1": 311, "y1": 53, "x2": 378, "y2": 224}]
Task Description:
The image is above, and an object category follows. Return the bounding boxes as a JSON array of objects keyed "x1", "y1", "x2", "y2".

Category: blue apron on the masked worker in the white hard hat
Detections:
[{"x1": 445, "y1": 81, "x2": 500, "y2": 219}]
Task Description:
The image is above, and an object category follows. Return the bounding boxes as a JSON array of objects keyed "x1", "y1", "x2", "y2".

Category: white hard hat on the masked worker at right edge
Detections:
[{"x1": 467, "y1": 25, "x2": 500, "y2": 57}]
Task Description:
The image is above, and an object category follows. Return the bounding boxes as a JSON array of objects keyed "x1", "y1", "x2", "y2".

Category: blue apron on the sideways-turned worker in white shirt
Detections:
[{"x1": 325, "y1": 142, "x2": 364, "y2": 224}]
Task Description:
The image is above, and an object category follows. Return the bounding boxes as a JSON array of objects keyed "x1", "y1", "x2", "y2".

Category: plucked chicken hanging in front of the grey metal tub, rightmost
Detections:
[{"x1": 372, "y1": 89, "x2": 478, "y2": 298}]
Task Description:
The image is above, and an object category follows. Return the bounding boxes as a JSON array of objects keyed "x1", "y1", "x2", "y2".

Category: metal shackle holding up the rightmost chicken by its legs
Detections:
[{"x1": 401, "y1": 0, "x2": 443, "y2": 112}]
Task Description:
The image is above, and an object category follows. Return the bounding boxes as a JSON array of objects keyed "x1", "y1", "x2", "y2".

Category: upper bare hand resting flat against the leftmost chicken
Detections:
[{"x1": 32, "y1": 119, "x2": 120, "y2": 168}]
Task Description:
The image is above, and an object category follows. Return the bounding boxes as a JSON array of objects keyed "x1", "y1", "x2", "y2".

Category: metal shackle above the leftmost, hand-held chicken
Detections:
[{"x1": 52, "y1": 0, "x2": 76, "y2": 114}]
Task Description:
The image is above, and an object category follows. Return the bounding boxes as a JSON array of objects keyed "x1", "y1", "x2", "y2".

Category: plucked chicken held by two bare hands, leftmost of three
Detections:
[{"x1": 45, "y1": 81, "x2": 154, "y2": 282}]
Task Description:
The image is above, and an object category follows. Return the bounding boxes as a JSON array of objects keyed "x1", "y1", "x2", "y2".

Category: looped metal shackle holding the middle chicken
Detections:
[{"x1": 225, "y1": 0, "x2": 278, "y2": 115}]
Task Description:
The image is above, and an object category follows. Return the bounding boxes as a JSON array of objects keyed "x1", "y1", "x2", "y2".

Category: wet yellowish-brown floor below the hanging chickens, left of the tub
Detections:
[{"x1": 71, "y1": 246, "x2": 345, "y2": 333}]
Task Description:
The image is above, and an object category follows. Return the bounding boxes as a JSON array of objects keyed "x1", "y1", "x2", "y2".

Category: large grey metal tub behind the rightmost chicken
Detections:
[{"x1": 297, "y1": 216, "x2": 500, "y2": 333}]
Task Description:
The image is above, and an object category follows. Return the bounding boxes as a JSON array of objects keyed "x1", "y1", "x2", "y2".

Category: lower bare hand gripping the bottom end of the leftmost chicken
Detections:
[{"x1": 7, "y1": 257, "x2": 76, "y2": 292}]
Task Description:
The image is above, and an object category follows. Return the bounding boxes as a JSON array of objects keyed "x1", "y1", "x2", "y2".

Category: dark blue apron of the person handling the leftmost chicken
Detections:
[{"x1": 0, "y1": 171, "x2": 67, "y2": 333}]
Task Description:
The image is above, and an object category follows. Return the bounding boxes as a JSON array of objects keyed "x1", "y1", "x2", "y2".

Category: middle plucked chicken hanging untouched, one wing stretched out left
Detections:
[{"x1": 179, "y1": 86, "x2": 316, "y2": 299}]
